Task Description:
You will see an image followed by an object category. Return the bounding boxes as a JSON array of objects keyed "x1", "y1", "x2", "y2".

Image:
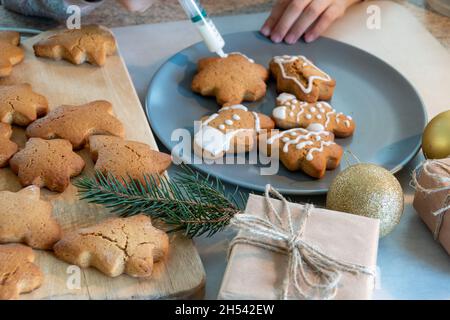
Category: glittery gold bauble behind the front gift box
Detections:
[{"x1": 327, "y1": 163, "x2": 404, "y2": 237}]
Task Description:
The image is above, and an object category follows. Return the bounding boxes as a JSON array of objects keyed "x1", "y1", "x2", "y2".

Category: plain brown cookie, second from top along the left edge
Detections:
[{"x1": 0, "y1": 83, "x2": 48, "y2": 126}]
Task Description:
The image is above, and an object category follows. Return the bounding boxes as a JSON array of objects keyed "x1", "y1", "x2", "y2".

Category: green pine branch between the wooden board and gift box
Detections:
[{"x1": 75, "y1": 165, "x2": 246, "y2": 237}]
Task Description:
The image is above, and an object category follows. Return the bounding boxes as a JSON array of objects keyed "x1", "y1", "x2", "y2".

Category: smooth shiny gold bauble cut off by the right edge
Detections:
[{"x1": 422, "y1": 110, "x2": 450, "y2": 159}]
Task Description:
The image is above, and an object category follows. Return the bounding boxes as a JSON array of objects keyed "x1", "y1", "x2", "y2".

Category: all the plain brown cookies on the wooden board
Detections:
[{"x1": 0, "y1": 25, "x2": 172, "y2": 299}]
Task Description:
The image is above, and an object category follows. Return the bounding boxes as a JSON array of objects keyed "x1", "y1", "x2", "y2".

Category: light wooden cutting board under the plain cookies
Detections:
[{"x1": 0, "y1": 33, "x2": 205, "y2": 299}]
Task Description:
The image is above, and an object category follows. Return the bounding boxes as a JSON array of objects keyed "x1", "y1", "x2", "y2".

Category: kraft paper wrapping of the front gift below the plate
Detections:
[{"x1": 218, "y1": 195, "x2": 379, "y2": 300}]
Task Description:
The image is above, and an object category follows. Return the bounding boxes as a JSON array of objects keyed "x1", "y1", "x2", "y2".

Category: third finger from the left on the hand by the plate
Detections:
[{"x1": 285, "y1": 0, "x2": 331, "y2": 44}]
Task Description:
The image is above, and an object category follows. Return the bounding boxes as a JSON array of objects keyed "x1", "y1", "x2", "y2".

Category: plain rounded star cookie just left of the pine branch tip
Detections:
[{"x1": 9, "y1": 138, "x2": 85, "y2": 192}]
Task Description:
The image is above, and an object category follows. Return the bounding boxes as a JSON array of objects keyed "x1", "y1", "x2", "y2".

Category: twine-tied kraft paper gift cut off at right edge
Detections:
[{"x1": 413, "y1": 158, "x2": 450, "y2": 254}]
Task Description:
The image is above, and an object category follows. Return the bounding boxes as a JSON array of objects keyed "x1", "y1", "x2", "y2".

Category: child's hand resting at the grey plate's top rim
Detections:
[{"x1": 261, "y1": 0, "x2": 360, "y2": 44}]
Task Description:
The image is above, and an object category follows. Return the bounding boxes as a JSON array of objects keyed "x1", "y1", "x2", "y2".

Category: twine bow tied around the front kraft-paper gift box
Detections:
[{"x1": 228, "y1": 185, "x2": 375, "y2": 300}]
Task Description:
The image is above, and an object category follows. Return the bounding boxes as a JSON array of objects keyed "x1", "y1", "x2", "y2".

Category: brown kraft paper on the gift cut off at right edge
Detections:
[{"x1": 413, "y1": 158, "x2": 450, "y2": 254}]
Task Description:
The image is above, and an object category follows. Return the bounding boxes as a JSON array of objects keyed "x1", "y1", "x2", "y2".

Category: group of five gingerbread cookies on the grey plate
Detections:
[{"x1": 192, "y1": 53, "x2": 355, "y2": 179}]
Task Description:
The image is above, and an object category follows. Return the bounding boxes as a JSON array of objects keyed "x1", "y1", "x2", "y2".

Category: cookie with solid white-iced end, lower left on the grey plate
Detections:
[{"x1": 194, "y1": 105, "x2": 275, "y2": 159}]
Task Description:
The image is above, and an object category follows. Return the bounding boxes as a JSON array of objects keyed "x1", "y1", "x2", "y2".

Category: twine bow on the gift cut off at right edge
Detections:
[{"x1": 411, "y1": 160, "x2": 450, "y2": 240}]
